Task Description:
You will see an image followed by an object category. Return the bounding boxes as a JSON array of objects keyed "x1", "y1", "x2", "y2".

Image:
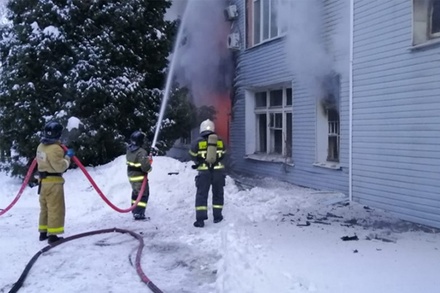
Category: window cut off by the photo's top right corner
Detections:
[{"x1": 413, "y1": 0, "x2": 440, "y2": 45}]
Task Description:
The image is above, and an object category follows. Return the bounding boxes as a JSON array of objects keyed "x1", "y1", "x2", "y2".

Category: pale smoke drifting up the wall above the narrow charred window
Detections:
[{"x1": 278, "y1": 0, "x2": 349, "y2": 99}]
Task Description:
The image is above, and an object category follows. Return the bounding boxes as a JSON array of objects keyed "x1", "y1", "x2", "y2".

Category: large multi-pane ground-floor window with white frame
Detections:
[{"x1": 254, "y1": 88, "x2": 292, "y2": 158}]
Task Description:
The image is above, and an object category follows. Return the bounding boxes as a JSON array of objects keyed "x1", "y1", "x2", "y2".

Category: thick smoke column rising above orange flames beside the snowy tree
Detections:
[{"x1": 175, "y1": 0, "x2": 232, "y2": 105}]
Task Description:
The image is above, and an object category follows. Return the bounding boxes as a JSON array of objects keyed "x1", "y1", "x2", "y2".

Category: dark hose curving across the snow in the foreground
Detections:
[{"x1": 9, "y1": 228, "x2": 163, "y2": 293}]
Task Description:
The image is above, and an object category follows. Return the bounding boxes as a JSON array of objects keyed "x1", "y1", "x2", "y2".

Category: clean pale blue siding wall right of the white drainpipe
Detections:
[{"x1": 353, "y1": 0, "x2": 440, "y2": 227}]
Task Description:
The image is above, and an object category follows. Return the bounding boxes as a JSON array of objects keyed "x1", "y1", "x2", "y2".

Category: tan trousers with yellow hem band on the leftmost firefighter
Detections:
[{"x1": 38, "y1": 182, "x2": 66, "y2": 235}]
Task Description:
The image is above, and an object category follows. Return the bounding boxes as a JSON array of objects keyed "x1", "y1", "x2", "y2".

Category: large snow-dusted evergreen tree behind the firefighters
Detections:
[{"x1": 0, "y1": 0, "x2": 191, "y2": 176}]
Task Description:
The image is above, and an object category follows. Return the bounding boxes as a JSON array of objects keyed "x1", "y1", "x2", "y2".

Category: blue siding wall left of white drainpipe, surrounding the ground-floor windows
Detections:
[{"x1": 230, "y1": 0, "x2": 349, "y2": 194}]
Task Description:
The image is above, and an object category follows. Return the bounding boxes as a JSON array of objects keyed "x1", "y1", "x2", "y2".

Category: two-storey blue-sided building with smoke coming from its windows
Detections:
[{"x1": 227, "y1": 0, "x2": 440, "y2": 228}]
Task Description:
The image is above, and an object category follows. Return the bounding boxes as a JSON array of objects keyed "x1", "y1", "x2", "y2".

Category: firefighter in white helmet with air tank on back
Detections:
[{"x1": 189, "y1": 119, "x2": 226, "y2": 228}]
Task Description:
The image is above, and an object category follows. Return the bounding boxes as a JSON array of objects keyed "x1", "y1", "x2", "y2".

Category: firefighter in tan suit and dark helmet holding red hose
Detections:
[{"x1": 36, "y1": 121, "x2": 74, "y2": 244}]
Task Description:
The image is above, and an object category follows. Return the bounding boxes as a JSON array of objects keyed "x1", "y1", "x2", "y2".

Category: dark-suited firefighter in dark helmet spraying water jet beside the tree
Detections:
[{"x1": 126, "y1": 131, "x2": 153, "y2": 220}]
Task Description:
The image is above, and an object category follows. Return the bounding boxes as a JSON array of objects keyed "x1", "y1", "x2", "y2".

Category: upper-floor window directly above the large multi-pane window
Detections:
[{"x1": 246, "y1": 0, "x2": 280, "y2": 46}]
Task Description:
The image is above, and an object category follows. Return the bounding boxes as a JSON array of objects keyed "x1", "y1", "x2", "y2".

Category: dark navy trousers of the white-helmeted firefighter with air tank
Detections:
[{"x1": 195, "y1": 170, "x2": 225, "y2": 221}]
